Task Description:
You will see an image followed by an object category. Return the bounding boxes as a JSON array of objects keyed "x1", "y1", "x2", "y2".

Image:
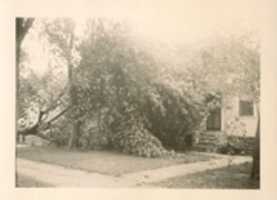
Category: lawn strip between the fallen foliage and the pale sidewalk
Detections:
[{"x1": 17, "y1": 147, "x2": 212, "y2": 176}]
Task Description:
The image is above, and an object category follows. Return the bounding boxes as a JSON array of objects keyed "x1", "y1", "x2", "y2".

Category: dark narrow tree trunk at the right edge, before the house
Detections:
[{"x1": 251, "y1": 109, "x2": 260, "y2": 180}]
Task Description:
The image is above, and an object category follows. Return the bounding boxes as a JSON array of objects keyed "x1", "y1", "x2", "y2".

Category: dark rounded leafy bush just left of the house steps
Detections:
[{"x1": 143, "y1": 83, "x2": 204, "y2": 150}]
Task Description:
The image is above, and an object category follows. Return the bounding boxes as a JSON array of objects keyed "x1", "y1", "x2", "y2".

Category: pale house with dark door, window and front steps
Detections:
[{"x1": 194, "y1": 96, "x2": 258, "y2": 151}]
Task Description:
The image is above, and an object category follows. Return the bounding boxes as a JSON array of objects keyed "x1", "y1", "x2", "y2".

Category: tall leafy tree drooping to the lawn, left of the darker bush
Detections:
[{"x1": 73, "y1": 19, "x2": 168, "y2": 156}]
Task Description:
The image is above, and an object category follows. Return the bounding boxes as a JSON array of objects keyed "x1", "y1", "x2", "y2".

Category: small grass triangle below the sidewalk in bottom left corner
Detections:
[{"x1": 16, "y1": 174, "x2": 53, "y2": 188}]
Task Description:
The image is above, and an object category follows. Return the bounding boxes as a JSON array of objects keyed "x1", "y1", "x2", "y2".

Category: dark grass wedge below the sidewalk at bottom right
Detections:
[{"x1": 150, "y1": 163, "x2": 259, "y2": 189}]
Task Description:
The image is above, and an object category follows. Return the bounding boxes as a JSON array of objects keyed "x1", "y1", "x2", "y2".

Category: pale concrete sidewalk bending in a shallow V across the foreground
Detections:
[{"x1": 17, "y1": 156, "x2": 252, "y2": 187}]
